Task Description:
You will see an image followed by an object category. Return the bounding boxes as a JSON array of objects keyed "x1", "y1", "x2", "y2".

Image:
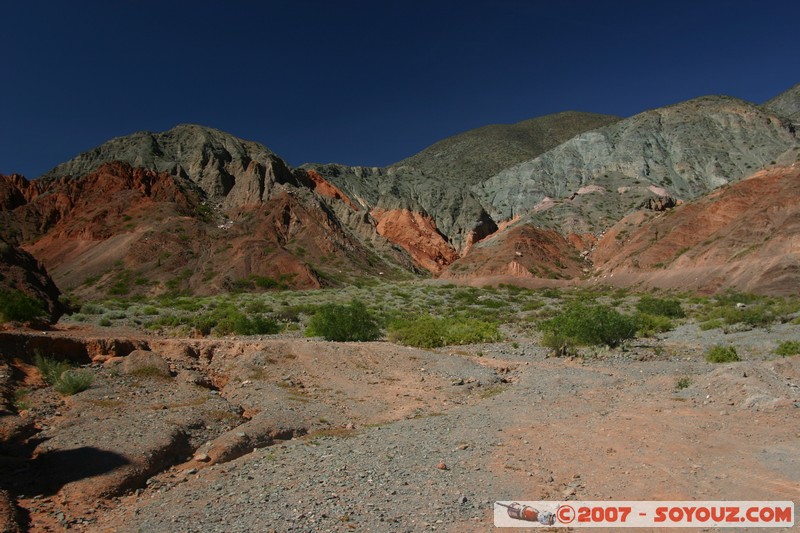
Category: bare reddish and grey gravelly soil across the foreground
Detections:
[{"x1": 0, "y1": 324, "x2": 800, "y2": 532}]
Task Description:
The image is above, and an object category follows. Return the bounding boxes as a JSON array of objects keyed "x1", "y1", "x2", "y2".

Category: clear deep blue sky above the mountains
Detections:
[{"x1": 0, "y1": 0, "x2": 800, "y2": 178}]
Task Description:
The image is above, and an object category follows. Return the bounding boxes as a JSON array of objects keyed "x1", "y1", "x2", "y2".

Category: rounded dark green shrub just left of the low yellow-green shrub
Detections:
[{"x1": 306, "y1": 300, "x2": 381, "y2": 342}]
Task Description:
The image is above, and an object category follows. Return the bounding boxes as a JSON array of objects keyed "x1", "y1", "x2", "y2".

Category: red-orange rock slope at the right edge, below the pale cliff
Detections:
[{"x1": 592, "y1": 165, "x2": 800, "y2": 294}]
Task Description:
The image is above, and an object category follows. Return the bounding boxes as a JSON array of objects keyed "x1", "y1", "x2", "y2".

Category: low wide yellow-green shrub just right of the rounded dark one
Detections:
[{"x1": 387, "y1": 315, "x2": 502, "y2": 348}]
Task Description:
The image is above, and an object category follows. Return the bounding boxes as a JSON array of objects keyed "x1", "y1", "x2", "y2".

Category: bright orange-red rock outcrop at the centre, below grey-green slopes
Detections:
[{"x1": 370, "y1": 208, "x2": 458, "y2": 274}]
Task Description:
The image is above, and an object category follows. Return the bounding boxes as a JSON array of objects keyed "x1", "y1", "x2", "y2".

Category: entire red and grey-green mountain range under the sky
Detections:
[{"x1": 0, "y1": 85, "x2": 800, "y2": 316}]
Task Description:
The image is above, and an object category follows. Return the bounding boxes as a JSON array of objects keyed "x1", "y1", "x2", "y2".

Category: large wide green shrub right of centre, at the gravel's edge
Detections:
[{"x1": 539, "y1": 304, "x2": 636, "y2": 348}]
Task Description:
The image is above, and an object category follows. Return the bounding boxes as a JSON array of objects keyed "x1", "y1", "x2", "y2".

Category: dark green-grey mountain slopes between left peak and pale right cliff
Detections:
[{"x1": 304, "y1": 112, "x2": 619, "y2": 250}]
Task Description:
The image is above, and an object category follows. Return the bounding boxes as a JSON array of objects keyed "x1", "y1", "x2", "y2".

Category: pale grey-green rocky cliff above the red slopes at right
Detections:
[{"x1": 473, "y1": 96, "x2": 797, "y2": 220}]
